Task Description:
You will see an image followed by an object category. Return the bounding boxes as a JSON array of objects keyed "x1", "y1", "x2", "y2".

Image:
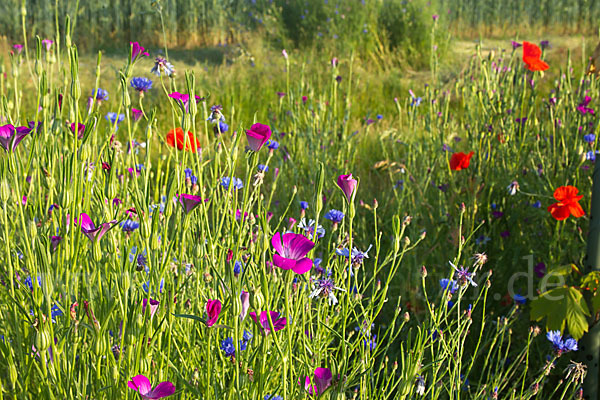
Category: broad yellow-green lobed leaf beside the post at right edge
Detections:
[{"x1": 530, "y1": 287, "x2": 590, "y2": 339}]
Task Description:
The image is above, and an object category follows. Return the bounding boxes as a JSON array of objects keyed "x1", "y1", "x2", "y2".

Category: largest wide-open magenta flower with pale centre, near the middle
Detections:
[{"x1": 271, "y1": 232, "x2": 315, "y2": 274}]
